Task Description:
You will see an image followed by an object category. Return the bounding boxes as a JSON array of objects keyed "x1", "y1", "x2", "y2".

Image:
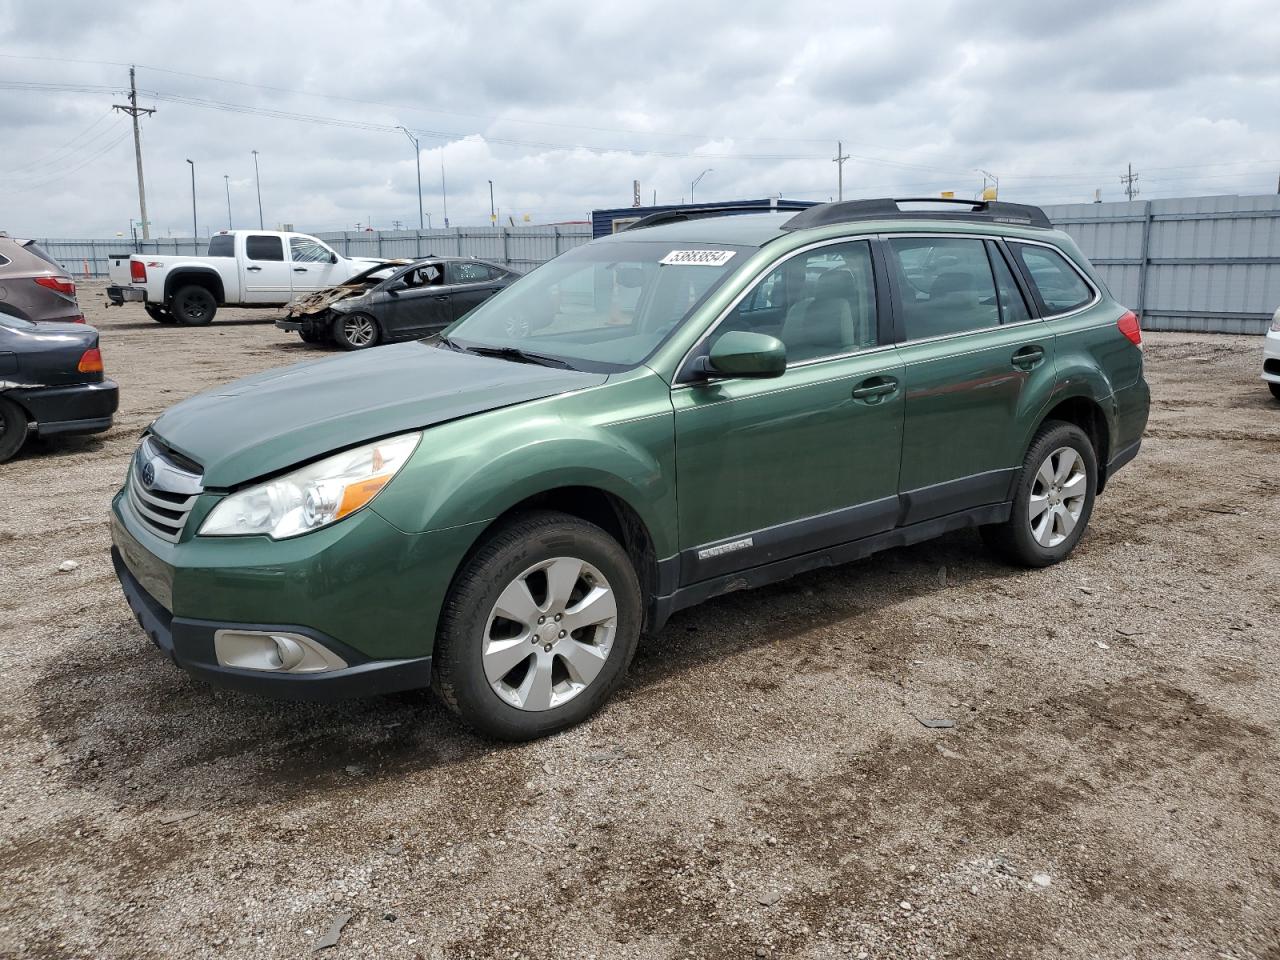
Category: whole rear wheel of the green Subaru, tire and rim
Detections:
[{"x1": 982, "y1": 420, "x2": 1098, "y2": 567}]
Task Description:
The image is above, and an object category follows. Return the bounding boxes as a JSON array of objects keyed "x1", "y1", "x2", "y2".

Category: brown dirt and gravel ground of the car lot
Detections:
[{"x1": 0, "y1": 284, "x2": 1280, "y2": 960}]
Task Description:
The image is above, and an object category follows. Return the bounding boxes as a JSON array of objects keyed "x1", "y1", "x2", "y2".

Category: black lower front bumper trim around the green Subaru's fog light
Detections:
[{"x1": 111, "y1": 547, "x2": 431, "y2": 700}]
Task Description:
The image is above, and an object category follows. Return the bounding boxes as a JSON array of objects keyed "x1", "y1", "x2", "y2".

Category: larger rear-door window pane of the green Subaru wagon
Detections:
[{"x1": 888, "y1": 237, "x2": 1000, "y2": 340}]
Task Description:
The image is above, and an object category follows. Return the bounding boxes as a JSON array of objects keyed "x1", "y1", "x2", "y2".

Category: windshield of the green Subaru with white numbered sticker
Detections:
[{"x1": 445, "y1": 241, "x2": 755, "y2": 371}]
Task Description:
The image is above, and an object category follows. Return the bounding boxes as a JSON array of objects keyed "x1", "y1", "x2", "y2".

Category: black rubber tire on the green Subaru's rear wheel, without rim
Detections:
[{"x1": 982, "y1": 420, "x2": 1098, "y2": 567}]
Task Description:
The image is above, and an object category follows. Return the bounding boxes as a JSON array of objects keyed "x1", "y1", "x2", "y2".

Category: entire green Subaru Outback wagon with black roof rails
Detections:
[{"x1": 111, "y1": 200, "x2": 1149, "y2": 740}]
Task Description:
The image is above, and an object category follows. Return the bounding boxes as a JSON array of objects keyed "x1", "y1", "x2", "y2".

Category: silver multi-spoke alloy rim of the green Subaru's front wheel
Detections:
[{"x1": 481, "y1": 557, "x2": 618, "y2": 710}]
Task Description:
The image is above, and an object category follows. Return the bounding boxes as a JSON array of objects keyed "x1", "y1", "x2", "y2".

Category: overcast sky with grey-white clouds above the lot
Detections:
[{"x1": 0, "y1": 0, "x2": 1280, "y2": 238}]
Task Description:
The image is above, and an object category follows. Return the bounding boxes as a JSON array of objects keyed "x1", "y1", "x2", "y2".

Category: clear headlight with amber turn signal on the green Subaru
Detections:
[{"x1": 200, "y1": 433, "x2": 422, "y2": 540}]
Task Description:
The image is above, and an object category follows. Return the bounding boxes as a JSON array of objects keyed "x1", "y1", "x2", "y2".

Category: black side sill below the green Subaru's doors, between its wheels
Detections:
[{"x1": 649, "y1": 502, "x2": 1012, "y2": 634}]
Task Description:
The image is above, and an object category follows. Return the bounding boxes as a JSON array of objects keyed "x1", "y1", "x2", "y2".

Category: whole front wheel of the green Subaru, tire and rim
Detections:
[{"x1": 431, "y1": 511, "x2": 643, "y2": 740}]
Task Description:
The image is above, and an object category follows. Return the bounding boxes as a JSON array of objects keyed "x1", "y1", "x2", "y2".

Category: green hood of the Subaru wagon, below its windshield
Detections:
[{"x1": 151, "y1": 340, "x2": 608, "y2": 488}]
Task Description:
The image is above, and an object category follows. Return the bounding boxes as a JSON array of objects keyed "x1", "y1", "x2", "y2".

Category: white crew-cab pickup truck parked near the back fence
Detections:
[{"x1": 106, "y1": 230, "x2": 383, "y2": 326}]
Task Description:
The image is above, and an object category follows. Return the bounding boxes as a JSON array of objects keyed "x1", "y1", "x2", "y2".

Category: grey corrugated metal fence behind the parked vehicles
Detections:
[{"x1": 30, "y1": 195, "x2": 1280, "y2": 333}]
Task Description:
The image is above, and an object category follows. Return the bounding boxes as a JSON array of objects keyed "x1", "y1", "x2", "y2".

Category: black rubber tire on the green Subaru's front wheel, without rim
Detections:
[{"x1": 431, "y1": 511, "x2": 643, "y2": 741}]
